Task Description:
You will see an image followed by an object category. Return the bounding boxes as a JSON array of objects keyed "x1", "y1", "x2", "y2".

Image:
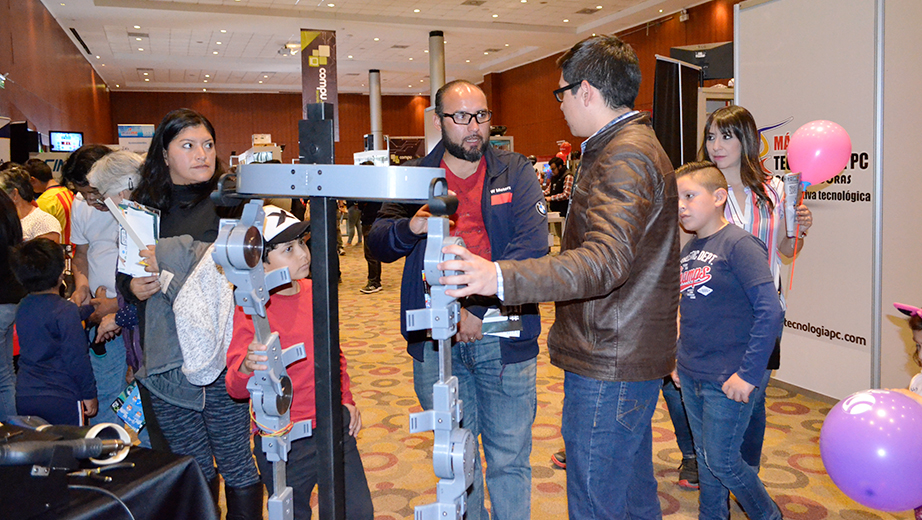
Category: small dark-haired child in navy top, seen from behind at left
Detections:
[{"x1": 9, "y1": 238, "x2": 99, "y2": 426}]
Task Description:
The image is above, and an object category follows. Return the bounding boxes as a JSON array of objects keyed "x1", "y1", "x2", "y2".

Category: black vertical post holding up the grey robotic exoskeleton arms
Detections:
[{"x1": 299, "y1": 105, "x2": 346, "y2": 520}]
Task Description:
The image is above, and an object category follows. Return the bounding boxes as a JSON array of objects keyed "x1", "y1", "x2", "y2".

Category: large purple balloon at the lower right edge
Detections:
[{"x1": 820, "y1": 390, "x2": 922, "y2": 511}]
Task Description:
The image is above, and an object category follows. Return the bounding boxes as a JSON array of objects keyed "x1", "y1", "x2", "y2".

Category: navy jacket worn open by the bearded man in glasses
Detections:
[{"x1": 368, "y1": 143, "x2": 548, "y2": 365}]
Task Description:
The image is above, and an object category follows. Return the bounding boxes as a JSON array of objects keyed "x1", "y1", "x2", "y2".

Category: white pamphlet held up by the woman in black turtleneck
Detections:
[{"x1": 106, "y1": 197, "x2": 160, "y2": 277}]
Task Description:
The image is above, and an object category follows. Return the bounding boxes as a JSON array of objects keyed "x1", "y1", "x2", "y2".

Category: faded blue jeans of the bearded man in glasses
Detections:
[{"x1": 413, "y1": 336, "x2": 538, "y2": 520}]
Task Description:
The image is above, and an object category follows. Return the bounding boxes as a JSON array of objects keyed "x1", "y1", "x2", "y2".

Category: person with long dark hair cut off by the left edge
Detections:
[{"x1": 0, "y1": 190, "x2": 26, "y2": 422}]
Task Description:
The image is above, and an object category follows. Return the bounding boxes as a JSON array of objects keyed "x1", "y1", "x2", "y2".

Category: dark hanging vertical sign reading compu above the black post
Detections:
[{"x1": 301, "y1": 29, "x2": 339, "y2": 142}]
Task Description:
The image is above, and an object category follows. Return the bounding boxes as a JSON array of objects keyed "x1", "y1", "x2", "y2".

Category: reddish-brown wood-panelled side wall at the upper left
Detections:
[{"x1": 0, "y1": 0, "x2": 115, "y2": 143}]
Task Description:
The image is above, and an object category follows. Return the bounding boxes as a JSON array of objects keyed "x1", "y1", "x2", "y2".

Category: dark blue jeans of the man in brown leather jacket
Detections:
[{"x1": 560, "y1": 372, "x2": 663, "y2": 520}]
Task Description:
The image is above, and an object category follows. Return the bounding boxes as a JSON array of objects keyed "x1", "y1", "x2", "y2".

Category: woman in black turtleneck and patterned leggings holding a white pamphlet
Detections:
[{"x1": 119, "y1": 109, "x2": 263, "y2": 519}]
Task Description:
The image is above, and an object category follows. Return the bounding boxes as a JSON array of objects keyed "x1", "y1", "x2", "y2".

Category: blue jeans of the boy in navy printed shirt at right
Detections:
[{"x1": 679, "y1": 369, "x2": 781, "y2": 520}]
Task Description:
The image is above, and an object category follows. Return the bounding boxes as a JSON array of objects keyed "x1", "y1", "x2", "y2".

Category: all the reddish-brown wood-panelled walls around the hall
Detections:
[{"x1": 0, "y1": 0, "x2": 740, "y2": 163}]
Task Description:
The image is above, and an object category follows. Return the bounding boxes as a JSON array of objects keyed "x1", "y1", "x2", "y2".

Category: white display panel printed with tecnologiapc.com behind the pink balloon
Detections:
[{"x1": 734, "y1": 0, "x2": 875, "y2": 398}]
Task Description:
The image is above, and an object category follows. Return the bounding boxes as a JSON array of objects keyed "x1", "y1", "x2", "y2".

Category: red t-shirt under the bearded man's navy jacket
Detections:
[{"x1": 439, "y1": 157, "x2": 493, "y2": 260}]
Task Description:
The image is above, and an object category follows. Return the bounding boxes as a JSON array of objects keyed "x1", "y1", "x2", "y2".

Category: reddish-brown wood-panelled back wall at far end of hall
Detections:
[{"x1": 111, "y1": 92, "x2": 429, "y2": 164}]
